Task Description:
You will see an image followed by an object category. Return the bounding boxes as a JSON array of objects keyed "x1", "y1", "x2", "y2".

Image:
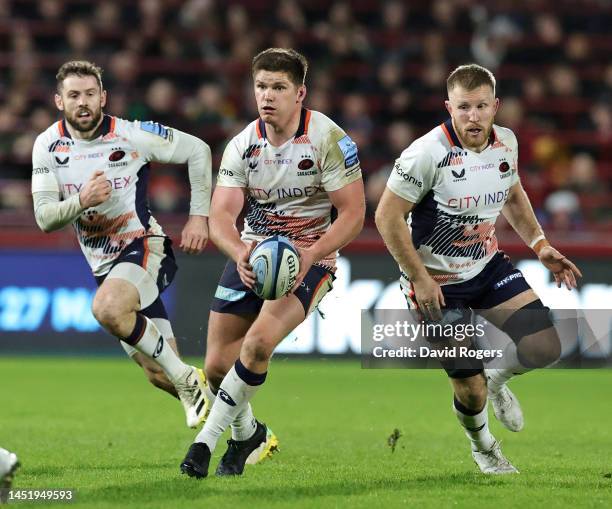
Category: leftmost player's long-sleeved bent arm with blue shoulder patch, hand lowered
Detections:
[{"x1": 136, "y1": 122, "x2": 212, "y2": 254}]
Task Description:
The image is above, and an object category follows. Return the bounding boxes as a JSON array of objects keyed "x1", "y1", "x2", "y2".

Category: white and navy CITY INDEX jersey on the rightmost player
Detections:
[{"x1": 387, "y1": 119, "x2": 519, "y2": 284}]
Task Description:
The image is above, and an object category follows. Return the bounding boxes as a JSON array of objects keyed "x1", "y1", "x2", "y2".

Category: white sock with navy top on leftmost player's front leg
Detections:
[{"x1": 126, "y1": 313, "x2": 190, "y2": 383}]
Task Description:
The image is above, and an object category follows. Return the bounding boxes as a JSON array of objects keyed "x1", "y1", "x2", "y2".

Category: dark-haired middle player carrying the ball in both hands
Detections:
[{"x1": 180, "y1": 48, "x2": 365, "y2": 478}]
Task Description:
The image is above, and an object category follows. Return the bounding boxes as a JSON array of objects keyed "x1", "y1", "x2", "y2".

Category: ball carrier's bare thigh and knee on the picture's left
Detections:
[{"x1": 204, "y1": 311, "x2": 257, "y2": 378}]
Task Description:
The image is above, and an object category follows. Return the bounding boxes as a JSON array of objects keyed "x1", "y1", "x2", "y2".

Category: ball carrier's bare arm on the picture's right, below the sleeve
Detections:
[{"x1": 293, "y1": 178, "x2": 365, "y2": 290}]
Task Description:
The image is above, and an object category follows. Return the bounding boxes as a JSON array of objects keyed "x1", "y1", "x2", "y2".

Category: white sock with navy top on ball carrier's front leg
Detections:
[{"x1": 194, "y1": 359, "x2": 267, "y2": 452}]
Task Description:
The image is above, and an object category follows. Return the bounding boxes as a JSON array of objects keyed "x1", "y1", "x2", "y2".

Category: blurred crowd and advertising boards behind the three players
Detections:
[{"x1": 0, "y1": 0, "x2": 612, "y2": 355}]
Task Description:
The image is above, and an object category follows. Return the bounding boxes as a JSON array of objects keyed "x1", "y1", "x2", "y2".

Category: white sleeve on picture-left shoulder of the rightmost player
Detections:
[{"x1": 387, "y1": 145, "x2": 435, "y2": 203}]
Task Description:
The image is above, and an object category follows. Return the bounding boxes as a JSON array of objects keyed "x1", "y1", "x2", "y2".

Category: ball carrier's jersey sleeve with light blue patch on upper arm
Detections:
[{"x1": 321, "y1": 126, "x2": 361, "y2": 191}]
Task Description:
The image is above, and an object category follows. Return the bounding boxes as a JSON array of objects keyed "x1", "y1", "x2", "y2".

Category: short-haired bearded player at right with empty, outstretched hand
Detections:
[{"x1": 376, "y1": 64, "x2": 581, "y2": 474}]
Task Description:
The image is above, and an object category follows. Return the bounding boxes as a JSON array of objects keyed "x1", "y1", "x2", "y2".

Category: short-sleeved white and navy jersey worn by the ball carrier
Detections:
[{"x1": 217, "y1": 108, "x2": 361, "y2": 269}]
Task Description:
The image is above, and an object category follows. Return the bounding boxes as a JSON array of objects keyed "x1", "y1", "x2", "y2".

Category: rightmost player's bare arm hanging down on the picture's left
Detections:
[{"x1": 375, "y1": 187, "x2": 445, "y2": 320}]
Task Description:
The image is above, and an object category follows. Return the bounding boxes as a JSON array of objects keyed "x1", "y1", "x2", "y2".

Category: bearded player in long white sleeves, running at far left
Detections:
[{"x1": 32, "y1": 61, "x2": 211, "y2": 427}]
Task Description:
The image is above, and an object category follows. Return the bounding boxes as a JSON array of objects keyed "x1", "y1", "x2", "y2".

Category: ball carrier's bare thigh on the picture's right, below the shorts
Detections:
[{"x1": 244, "y1": 294, "x2": 306, "y2": 360}]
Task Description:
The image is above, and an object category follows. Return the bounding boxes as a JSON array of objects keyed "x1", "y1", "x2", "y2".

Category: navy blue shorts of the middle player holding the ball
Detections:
[{"x1": 210, "y1": 260, "x2": 335, "y2": 316}]
